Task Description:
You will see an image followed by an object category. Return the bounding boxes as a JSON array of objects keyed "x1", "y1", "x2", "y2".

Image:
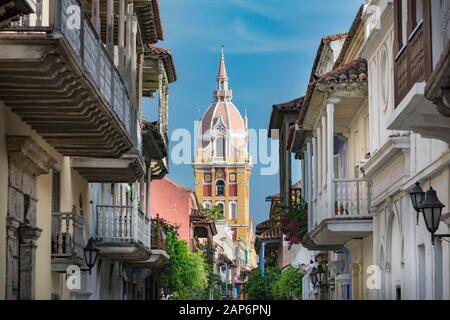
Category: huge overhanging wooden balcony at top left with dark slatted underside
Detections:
[{"x1": 0, "y1": 0, "x2": 138, "y2": 158}]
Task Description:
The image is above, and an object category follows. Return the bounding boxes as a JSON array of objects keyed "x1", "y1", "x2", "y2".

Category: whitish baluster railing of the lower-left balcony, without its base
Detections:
[{"x1": 96, "y1": 205, "x2": 150, "y2": 248}]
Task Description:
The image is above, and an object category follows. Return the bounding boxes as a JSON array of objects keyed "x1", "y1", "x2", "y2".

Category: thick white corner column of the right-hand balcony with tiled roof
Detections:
[{"x1": 327, "y1": 101, "x2": 334, "y2": 215}]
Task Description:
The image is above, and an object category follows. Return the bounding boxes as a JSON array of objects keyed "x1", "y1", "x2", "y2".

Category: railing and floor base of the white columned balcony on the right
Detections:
[{"x1": 309, "y1": 179, "x2": 372, "y2": 246}]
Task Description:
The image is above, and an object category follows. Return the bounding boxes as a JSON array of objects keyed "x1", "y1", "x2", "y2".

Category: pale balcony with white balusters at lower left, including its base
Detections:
[{"x1": 96, "y1": 205, "x2": 151, "y2": 261}]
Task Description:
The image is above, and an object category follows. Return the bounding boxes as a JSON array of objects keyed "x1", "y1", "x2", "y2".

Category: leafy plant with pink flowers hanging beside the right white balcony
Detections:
[{"x1": 279, "y1": 197, "x2": 308, "y2": 245}]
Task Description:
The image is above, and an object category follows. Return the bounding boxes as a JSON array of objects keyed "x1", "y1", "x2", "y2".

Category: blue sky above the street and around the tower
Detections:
[{"x1": 145, "y1": 0, "x2": 364, "y2": 224}]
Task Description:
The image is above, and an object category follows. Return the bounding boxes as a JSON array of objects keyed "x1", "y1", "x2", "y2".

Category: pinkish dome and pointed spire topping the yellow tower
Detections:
[{"x1": 199, "y1": 49, "x2": 247, "y2": 148}]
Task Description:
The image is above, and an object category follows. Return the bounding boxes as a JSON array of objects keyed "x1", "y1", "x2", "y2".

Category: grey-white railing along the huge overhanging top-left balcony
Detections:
[{"x1": 0, "y1": 0, "x2": 137, "y2": 146}]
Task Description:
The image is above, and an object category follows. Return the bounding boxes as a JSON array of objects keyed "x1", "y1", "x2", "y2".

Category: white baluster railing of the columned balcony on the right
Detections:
[{"x1": 309, "y1": 179, "x2": 371, "y2": 226}]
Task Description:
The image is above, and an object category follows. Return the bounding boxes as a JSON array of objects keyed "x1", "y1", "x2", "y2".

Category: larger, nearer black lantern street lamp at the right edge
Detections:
[{"x1": 420, "y1": 187, "x2": 450, "y2": 245}]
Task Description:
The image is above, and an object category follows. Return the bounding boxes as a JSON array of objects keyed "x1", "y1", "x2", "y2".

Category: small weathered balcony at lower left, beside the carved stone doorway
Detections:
[{"x1": 52, "y1": 209, "x2": 85, "y2": 273}]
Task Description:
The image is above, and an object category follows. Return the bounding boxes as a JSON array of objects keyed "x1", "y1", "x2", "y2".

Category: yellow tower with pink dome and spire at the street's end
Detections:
[{"x1": 193, "y1": 52, "x2": 256, "y2": 268}]
